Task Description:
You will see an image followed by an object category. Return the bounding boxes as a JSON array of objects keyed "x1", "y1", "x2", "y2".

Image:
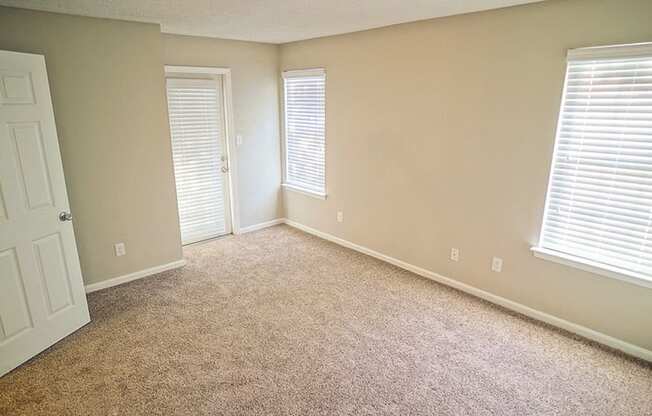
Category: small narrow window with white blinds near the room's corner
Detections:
[{"x1": 283, "y1": 69, "x2": 326, "y2": 198}]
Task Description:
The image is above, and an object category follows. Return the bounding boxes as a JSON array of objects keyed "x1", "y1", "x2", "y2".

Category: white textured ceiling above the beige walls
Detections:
[{"x1": 0, "y1": 0, "x2": 542, "y2": 43}]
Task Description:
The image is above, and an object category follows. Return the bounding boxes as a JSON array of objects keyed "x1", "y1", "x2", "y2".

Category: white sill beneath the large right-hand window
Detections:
[{"x1": 531, "y1": 247, "x2": 652, "y2": 288}]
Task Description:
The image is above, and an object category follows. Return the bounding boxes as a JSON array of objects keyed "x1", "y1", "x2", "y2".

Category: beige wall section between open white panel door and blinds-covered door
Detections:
[{"x1": 0, "y1": 7, "x2": 181, "y2": 284}]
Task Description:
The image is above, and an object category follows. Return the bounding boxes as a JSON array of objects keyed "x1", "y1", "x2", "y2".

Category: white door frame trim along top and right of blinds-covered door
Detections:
[{"x1": 165, "y1": 65, "x2": 240, "y2": 234}]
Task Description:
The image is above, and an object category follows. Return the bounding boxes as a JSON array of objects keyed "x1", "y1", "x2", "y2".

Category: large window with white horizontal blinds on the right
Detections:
[{"x1": 533, "y1": 44, "x2": 652, "y2": 286}]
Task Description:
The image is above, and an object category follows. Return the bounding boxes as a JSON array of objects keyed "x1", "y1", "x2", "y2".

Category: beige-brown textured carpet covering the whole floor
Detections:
[{"x1": 0, "y1": 226, "x2": 652, "y2": 416}]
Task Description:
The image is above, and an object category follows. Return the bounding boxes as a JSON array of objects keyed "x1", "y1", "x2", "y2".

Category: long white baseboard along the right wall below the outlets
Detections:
[{"x1": 285, "y1": 219, "x2": 652, "y2": 362}]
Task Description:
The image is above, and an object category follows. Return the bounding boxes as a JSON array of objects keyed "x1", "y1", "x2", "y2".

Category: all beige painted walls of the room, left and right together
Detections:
[{"x1": 0, "y1": 0, "x2": 652, "y2": 349}]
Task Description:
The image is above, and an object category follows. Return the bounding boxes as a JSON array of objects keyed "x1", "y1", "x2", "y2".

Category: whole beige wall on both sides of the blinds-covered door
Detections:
[{"x1": 0, "y1": 7, "x2": 283, "y2": 284}]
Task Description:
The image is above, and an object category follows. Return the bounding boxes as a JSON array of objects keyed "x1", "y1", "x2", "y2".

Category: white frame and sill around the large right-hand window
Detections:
[{"x1": 531, "y1": 43, "x2": 652, "y2": 288}]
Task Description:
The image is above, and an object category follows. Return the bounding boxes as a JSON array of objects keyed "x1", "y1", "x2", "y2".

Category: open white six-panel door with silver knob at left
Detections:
[{"x1": 0, "y1": 51, "x2": 90, "y2": 375}]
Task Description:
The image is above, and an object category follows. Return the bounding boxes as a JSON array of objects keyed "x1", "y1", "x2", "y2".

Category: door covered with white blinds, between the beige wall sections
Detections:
[{"x1": 167, "y1": 76, "x2": 231, "y2": 244}]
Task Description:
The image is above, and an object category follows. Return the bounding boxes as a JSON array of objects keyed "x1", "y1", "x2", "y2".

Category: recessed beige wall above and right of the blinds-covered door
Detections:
[{"x1": 163, "y1": 35, "x2": 283, "y2": 227}]
